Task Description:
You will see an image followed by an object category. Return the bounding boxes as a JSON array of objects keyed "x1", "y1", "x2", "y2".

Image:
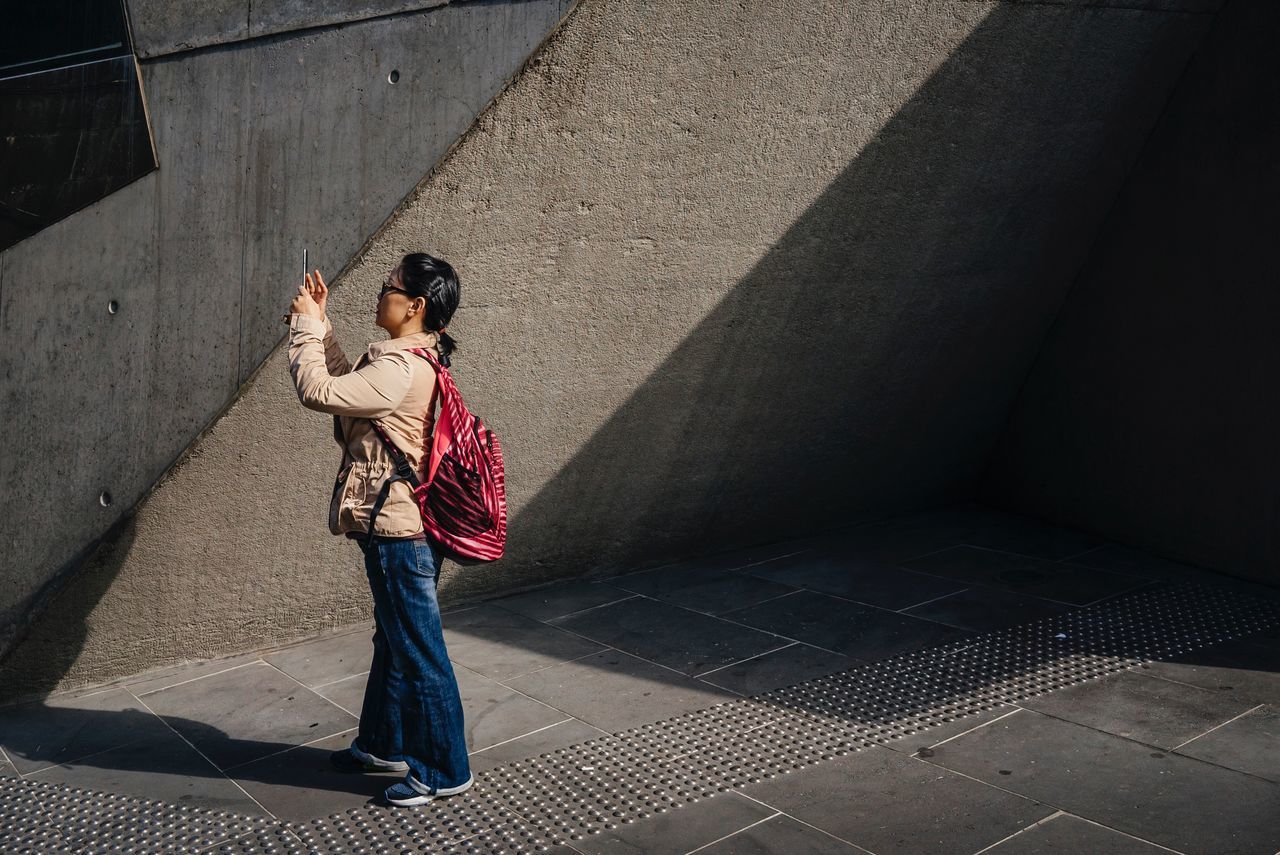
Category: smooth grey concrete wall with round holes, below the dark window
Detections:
[{"x1": 0, "y1": 0, "x2": 568, "y2": 675}]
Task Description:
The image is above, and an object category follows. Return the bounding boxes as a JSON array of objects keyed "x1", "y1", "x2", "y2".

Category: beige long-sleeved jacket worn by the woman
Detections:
[{"x1": 289, "y1": 315, "x2": 438, "y2": 538}]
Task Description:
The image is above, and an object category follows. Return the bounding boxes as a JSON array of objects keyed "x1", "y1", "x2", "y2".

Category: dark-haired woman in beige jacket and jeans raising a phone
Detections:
[{"x1": 289, "y1": 252, "x2": 472, "y2": 806}]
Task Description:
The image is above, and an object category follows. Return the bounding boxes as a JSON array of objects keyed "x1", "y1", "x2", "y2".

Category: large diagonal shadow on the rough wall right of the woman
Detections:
[{"x1": 486, "y1": 4, "x2": 1210, "y2": 588}]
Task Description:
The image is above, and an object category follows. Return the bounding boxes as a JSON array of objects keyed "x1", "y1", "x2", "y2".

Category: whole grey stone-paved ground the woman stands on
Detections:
[{"x1": 0, "y1": 508, "x2": 1280, "y2": 855}]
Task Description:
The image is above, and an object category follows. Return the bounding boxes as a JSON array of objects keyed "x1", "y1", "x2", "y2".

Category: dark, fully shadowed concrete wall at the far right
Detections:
[{"x1": 986, "y1": 0, "x2": 1280, "y2": 584}]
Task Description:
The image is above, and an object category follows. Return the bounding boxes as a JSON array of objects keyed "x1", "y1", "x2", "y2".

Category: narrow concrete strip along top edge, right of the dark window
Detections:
[{"x1": 127, "y1": 0, "x2": 449, "y2": 58}]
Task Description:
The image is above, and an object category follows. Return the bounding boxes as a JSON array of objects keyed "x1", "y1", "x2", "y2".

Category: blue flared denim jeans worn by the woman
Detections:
[{"x1": 356, "y1": 540, "x2": 471, "y2": 792}]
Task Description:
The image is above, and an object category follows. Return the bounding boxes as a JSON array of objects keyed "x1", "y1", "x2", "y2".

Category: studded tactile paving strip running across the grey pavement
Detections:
[{"x1": 0, "y1": 586, "x2": 1280, "y2": 855}]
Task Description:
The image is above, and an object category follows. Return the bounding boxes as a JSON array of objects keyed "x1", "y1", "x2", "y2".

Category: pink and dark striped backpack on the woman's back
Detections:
[{"x1": 369, "y1": 348, "x2": 507, "y2": 563}]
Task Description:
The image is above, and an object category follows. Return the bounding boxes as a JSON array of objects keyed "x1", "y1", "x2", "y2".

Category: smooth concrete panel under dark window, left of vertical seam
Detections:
[{"x1": 0, "y1": 173, "x2": 161, "y2": 649}]
